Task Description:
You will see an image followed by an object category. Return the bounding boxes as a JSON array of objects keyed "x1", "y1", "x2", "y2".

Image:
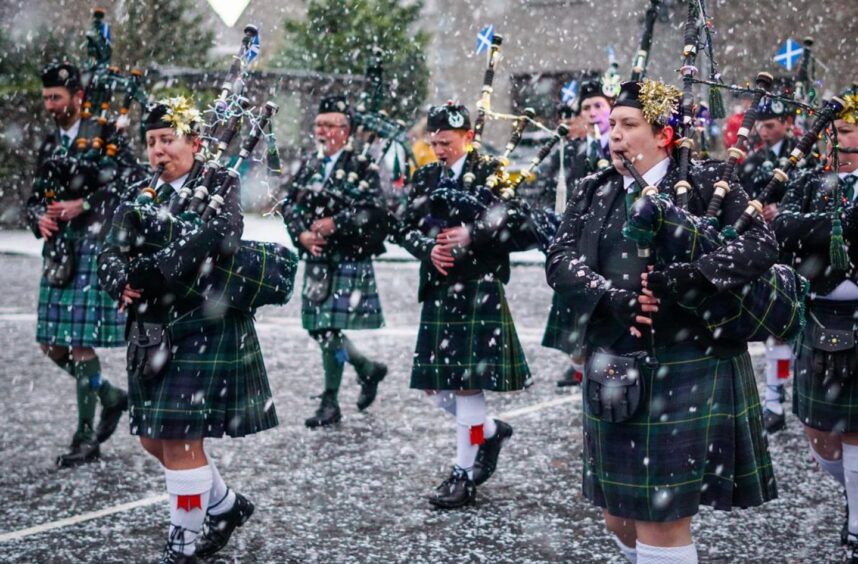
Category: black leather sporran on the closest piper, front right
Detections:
[{"x1": 583, "y1": 352, "x2": 643, "y2": 423}]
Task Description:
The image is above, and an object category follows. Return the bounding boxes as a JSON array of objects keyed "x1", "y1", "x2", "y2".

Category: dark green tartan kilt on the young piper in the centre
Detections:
[{"x1": 411, "y1": 279, "x2": 530, "y2": 392}]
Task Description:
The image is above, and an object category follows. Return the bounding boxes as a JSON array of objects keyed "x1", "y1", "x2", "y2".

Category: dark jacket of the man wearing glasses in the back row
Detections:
[{"x1": 281, "y1": 151, "x2": 389, "y2": 264}]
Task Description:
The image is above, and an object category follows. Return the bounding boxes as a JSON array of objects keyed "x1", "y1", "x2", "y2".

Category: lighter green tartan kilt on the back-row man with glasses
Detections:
[{"x1": 301, "y1": 260, "x2": 384, "y2": 331}]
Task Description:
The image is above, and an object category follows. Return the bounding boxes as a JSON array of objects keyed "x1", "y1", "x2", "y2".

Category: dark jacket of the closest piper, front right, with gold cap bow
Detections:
[{"x1": 546, "y1": 161, "x2": 777, "y2": 356}]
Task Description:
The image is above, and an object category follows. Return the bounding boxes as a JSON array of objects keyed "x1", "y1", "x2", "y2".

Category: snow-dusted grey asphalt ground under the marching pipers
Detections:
[{"x1": 0, "y1": 249, "x2": 843, "y2": 563}]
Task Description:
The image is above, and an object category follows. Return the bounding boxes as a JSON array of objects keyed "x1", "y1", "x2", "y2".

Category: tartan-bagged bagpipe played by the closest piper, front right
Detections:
[{"x1": 624, "y1": 73, "x2": 843, "y2": 341}]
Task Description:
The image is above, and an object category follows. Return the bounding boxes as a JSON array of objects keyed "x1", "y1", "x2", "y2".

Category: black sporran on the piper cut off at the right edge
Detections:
[{"x1": 809, "y1": 313, "x2": 858, "y2": 382}]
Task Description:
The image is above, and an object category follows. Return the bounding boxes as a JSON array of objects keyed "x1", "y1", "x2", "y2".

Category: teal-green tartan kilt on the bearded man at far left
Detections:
[{"x1": 36, "y1": 238, "x2": 125, "y2": 347}]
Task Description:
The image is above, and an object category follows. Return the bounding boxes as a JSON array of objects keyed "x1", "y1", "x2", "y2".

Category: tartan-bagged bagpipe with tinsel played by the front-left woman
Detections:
[{"x1": 113, "y1": 26, "x2": 298, "y2": 313}]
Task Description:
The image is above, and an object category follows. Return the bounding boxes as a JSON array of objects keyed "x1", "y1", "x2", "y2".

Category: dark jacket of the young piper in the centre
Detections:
[{"x1": 396, "y1": 151, "x2": 535, "y2": 301}]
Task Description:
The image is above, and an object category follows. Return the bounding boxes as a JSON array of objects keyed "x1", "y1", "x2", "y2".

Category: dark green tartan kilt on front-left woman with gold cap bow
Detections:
[{"x1": 128, "y1": 308, "x2": 277, "y2": 439}]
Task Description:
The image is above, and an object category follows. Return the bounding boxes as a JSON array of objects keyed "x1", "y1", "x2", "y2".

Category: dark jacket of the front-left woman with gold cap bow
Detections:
[{"x1": 98, "y1": 172, "x2": 244, "y2": 325}]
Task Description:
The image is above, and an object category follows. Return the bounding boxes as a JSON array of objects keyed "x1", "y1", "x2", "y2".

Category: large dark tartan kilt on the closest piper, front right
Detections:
[{"x1": 583, "y1": 344, "x2": 777, "y2": 522}]
